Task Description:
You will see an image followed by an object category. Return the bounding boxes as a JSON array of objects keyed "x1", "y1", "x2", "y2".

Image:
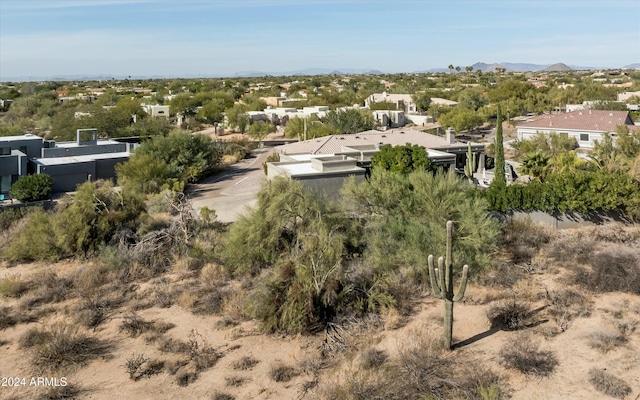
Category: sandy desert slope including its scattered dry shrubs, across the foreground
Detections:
[{"x1": 0, "y1": 223, "x2": 640, "y2": 400}]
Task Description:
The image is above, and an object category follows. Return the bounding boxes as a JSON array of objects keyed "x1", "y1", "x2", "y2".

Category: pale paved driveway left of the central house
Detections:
[{"x1": 188, "y1": 148, "x2": 274, "y2": 222}]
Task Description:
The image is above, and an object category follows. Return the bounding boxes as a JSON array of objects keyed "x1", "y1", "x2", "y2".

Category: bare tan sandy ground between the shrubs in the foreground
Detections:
[{"x1": 0, "y1": 252, "x2": 640, "y2": 400}]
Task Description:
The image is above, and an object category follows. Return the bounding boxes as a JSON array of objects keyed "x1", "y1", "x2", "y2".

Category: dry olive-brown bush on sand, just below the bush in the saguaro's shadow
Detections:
[{"x1": 500, "y1": 335, "x2": 558, "y2": 377}]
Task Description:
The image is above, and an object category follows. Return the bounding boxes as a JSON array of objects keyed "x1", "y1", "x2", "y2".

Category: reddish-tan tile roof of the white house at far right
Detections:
[{"x1": 518, "y1": 110, "x2": 633, "y2": 132}]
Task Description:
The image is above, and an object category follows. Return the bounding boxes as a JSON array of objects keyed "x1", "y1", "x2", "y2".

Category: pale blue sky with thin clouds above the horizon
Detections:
[{"x1": 0, "y1": 0, "x2": 640, "y2": 80}]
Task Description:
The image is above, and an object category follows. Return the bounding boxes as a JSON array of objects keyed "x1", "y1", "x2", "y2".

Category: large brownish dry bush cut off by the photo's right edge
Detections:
[{"x1": 574, "y1": 246, "x2": 640, "y2": 294}]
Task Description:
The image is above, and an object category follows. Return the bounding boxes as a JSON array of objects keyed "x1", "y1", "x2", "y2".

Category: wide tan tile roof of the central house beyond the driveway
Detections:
[{"x1": 280, "y1": 129, "x2": 464, "y2": 154}]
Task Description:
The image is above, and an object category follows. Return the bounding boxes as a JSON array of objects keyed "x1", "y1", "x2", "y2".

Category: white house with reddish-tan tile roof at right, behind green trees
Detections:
[{"x1": 517, "y1": 110, "x2": 635, "y2": 149}]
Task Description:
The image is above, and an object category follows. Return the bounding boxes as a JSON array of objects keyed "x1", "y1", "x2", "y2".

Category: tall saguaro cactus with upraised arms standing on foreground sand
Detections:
[{"x1": 428, "y1": 221, "x2": 469, "y2": 349}]
